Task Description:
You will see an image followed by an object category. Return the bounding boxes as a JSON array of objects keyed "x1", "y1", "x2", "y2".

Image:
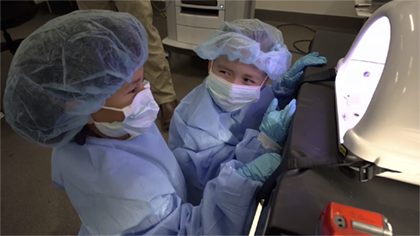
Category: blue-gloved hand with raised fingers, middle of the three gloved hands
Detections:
[{"x1": 260, "y1": 98, "x2": 296, "y2": 146}]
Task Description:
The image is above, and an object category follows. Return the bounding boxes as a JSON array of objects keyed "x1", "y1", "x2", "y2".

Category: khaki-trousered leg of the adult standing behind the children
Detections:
[{"x1": 115, "y1": 0, "x2": 178, "y2": 128}]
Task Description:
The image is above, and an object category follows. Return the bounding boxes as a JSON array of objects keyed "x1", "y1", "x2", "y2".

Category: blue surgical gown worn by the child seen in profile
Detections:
[{"x1": 52, "y1": 125, "x2": 261, "y2": 235}]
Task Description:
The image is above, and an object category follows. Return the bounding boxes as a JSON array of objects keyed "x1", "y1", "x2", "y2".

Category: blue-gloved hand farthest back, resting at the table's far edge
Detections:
[{"x1": 280, "y1": 52, "x2": 327, "y2": 89}]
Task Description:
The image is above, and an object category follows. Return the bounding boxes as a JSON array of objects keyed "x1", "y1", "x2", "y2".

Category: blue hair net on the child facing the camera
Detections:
[{"x1": 194, "y1": 19, "x2": 292, "y2": 80}]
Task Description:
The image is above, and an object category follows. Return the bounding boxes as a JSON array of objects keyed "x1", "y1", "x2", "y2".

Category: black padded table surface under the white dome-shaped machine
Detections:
[{"x1": 265, "y1": 32, "x2": 420, "y2": 235}]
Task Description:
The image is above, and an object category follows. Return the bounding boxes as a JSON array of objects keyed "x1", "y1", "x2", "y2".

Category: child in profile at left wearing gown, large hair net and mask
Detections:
[{"x1": 4, "y1": 10, "x2": 292, "y2": 235}]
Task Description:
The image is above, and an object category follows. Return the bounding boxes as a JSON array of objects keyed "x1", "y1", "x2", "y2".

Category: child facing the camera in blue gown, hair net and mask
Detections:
[{"x1": 169, "y1": 19, "x2": 326, "y2": 204}]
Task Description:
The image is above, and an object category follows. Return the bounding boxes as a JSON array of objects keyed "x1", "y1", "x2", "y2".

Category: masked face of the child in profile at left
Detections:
[{"x1": 75, "y1": 67, "x2": 159, "y2": 145}]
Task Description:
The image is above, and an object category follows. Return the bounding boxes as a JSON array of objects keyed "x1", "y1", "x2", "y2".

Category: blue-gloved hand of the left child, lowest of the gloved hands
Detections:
[{"x1": 236, "y1": 153, "x2": 281, "y2": 182}]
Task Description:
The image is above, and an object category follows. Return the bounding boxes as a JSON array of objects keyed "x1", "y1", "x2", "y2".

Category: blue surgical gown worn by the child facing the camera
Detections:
[{"x1": 168, "y1": 83, "x2": 274, "y2": 205}]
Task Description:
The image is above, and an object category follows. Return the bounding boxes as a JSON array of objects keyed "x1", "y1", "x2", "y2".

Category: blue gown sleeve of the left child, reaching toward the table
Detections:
[{"x1": 144, "y1": 161, "x2": 261, "y2": 235}]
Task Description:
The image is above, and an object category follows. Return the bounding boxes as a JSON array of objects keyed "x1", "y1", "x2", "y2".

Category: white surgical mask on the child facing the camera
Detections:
[{"x1": 205, "y1": 62, "x2": 267, "y2": 112}]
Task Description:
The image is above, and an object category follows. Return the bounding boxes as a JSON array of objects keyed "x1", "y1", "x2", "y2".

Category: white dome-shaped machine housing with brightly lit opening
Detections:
[{"x1": 336, "y1": 0, "x2": 420, "y2": 185}]
